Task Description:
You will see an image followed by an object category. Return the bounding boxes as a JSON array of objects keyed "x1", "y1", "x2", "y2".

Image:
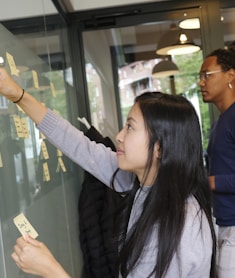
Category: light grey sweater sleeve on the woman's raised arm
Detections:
[{"x1": 37, "y1": 109, "x2": 132, "y2": 192}]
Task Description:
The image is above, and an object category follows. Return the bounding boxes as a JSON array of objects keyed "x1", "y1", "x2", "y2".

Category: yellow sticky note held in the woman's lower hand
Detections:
[{"x1": 13, "y1": 213, "x2": 38, "y2": 238}]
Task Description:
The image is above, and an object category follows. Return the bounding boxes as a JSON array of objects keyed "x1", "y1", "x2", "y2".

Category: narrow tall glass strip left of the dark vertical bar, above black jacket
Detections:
[{"x1": 83, "y1": 30, "x2": 119, "y2": 140}]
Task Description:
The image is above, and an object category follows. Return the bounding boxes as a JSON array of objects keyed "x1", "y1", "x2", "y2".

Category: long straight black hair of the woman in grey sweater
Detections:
[{"x1": 112, "y1": 92, "x2": 216, "y2": 278}]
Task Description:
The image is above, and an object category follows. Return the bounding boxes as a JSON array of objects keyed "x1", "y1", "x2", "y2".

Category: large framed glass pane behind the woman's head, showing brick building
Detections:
[{"x1": 83, "y1": 16, "x2": 210, "y2": 151}]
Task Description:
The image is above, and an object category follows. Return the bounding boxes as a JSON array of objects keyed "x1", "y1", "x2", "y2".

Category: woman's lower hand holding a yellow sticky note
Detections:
[{"x1": 11, "y1": 236, "x2": 70, "y2": 278}]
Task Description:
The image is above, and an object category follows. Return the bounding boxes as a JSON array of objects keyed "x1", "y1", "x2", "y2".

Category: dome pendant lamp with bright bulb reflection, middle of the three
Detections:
[{"x1": 156, "y1": 24, "x2": 200, "y2": 55}]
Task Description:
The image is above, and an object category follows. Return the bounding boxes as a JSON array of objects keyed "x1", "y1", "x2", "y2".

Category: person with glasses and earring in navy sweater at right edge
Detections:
[{"x1": 199, "y1": 46, "x2": 235, "y2": 278}]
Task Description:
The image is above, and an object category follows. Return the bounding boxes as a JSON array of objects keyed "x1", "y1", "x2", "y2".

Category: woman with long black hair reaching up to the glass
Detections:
[{"x1": 0, "y1": 68, "x2": 215, "y2": 278}]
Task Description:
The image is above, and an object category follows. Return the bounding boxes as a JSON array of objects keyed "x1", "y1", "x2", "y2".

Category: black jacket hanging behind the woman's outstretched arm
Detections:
[{"x1": 79, "y1": 127, "x2": 121, "y2": 278}]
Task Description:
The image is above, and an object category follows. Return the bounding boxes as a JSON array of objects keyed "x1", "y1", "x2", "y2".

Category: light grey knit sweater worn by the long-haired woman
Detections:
[{"x1": 37, "y1": 110, "x2": 212, "y2": 278}]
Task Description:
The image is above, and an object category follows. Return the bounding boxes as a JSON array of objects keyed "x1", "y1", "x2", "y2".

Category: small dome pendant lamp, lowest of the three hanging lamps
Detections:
[{"x1": 152, "y1": 60, "x2": 179, "y2": 78}]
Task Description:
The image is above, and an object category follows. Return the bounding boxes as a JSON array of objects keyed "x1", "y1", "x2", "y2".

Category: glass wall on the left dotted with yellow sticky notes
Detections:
[{"x1": 0, "y1": 5, "x2": 83, "y2": 278}]
